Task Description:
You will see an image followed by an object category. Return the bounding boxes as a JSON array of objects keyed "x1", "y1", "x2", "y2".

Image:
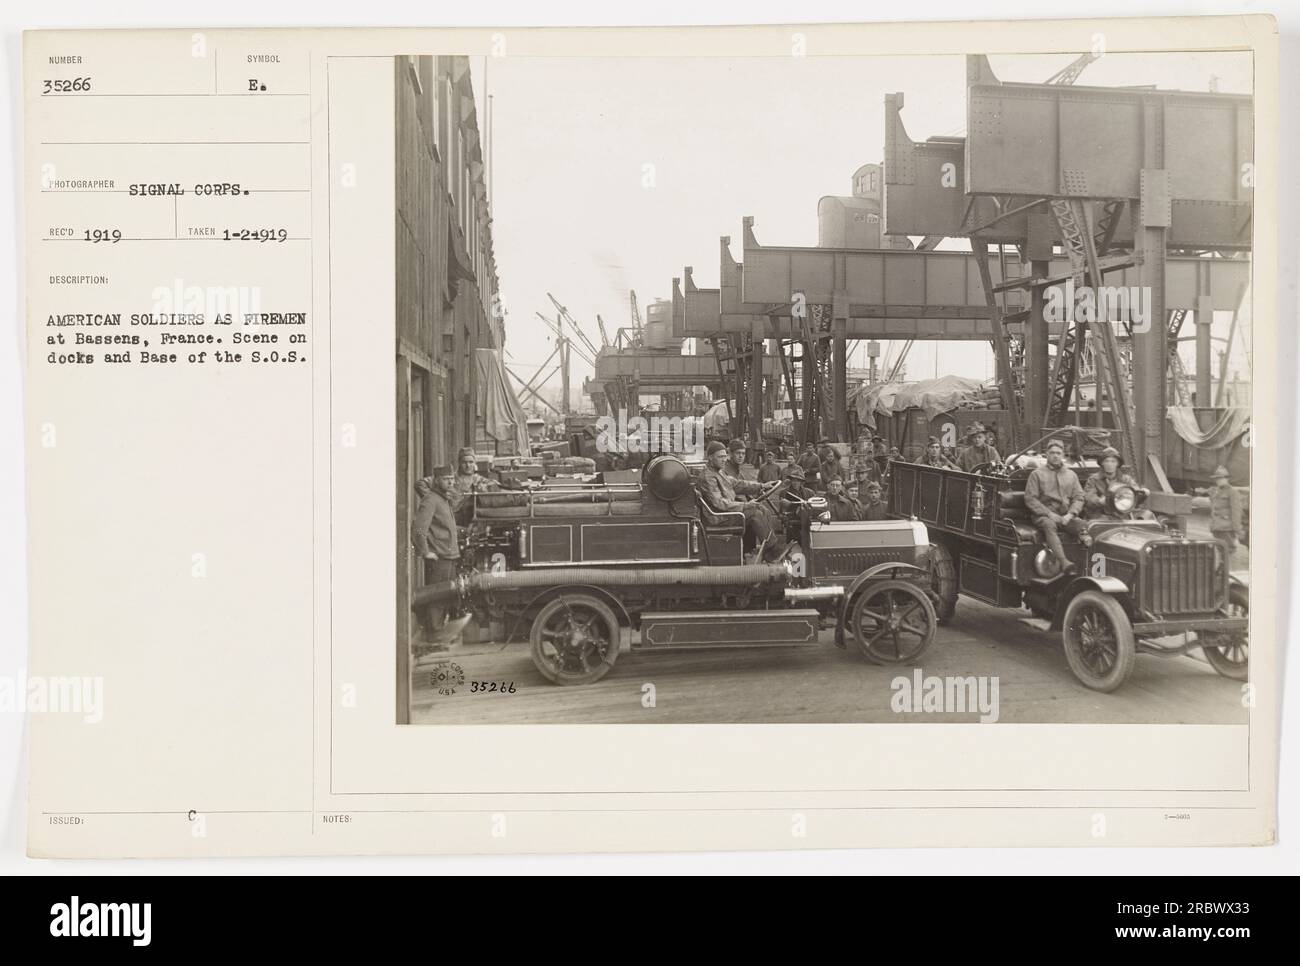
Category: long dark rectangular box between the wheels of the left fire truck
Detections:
[{"x1": 632, "y1": 608, "x2": 822, "y2": 650}]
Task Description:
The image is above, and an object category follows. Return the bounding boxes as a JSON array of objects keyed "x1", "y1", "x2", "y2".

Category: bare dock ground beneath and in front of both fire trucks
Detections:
[{"x1": 412, "y1": 597, "x2": 1247, "y2": 724}]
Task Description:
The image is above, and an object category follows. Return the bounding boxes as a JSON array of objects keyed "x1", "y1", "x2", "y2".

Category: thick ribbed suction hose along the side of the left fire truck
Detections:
[{"x1": 411, "y1": 563, "x2": 790, "y2": 611}]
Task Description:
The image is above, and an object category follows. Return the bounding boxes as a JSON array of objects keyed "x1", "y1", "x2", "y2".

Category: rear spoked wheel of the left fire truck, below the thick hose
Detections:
[{"x1": 529, "y1": 594, "x2": 619, "y2": 684}]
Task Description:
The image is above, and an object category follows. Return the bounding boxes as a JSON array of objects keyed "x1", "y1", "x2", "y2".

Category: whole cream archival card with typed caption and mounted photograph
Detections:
[{"x1": 20, "y1": 17, "x2": 1279, "y2": 857}]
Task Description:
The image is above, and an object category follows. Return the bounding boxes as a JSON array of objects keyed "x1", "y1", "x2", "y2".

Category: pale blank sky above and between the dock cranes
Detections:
[{"x1": 472, "y1": 53, "x2": 1252, "y2": 402}]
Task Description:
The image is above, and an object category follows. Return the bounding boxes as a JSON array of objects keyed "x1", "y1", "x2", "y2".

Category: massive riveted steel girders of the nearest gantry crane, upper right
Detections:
[{"x1": 884, "y1": 57, "x2": 1255, "y2": 251}]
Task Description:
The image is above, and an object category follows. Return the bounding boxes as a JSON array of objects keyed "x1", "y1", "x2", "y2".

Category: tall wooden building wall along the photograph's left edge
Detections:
[{"x1": 394, "y1": 56, "x2": 517, "y2": 712}]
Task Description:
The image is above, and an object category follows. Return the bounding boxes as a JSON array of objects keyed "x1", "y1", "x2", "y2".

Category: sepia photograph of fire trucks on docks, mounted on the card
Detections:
[{"x1": 400, "y1": 45, "x2": 1255, "y2": 725}]
